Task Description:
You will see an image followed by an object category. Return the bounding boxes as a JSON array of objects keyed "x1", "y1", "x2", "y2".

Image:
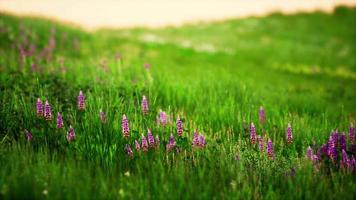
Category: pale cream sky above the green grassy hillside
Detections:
[{"x1": 0, "y1": 0, "x2": 356, "y2": 29}]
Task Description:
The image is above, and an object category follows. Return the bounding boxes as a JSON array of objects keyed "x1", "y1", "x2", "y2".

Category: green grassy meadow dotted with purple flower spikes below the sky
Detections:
[{"x1": 0, "y1": 7, "x2": 356, "y2": 199}]
